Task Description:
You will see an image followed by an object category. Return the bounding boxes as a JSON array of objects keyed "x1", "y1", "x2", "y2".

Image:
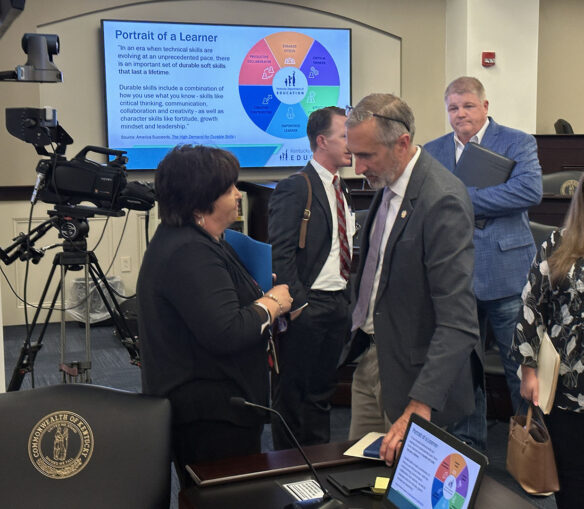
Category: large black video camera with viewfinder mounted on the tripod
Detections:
[{"x1": 6, "y1": 108, "x2": 155, "y2": 216}]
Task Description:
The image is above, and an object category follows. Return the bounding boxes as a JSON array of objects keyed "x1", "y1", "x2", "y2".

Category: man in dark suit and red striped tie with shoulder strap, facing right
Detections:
[{"x1": 268, "y1": 106, "x2": 355, "y2": 449}]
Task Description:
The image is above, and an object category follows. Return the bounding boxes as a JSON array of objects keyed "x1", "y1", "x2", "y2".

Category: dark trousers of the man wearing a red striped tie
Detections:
[{"x1": 272, "y1": 291, "x2": 348, "y2": 449}]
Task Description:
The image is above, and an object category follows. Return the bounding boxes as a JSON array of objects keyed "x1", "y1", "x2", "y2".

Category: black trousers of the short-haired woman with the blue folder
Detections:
[{"x1": 172, "y1": 421, "x2": 264, "y2": 489}]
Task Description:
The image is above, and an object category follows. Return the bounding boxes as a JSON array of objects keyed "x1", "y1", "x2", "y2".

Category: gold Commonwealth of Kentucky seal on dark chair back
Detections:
[{"x1": 28, "y1": 410, "x2": 94, "y2": 479}]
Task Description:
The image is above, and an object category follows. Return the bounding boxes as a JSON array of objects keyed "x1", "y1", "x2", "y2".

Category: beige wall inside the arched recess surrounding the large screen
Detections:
[{"x1": 41, "y1": 0, "x2": 401, "y2": 179}]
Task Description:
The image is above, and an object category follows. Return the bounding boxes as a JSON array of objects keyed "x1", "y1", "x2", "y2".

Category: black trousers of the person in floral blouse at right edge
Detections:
[{"x1": 545, "y1": 402, "x2": 584, "y2": 509}]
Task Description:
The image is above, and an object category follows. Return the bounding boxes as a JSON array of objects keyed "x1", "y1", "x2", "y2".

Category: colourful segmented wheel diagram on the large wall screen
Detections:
[{"x1": 239, "y1": 32, "x2": 340, "y2": 139}]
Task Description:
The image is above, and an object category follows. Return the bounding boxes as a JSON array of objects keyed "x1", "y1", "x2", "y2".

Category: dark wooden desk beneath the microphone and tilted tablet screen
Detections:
[{"x1": 179, "y1": 442, "x2": 534, "y2": 509}]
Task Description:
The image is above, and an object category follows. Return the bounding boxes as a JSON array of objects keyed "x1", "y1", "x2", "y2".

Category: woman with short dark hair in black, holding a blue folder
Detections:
[{"x1": 137, "y1": 145, "x2": 292, "y2": 481}]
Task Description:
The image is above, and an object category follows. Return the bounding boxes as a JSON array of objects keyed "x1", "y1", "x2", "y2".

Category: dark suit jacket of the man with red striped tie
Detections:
[{"x1": 268, "y1": 163, "x2": 350, "y2": 310}]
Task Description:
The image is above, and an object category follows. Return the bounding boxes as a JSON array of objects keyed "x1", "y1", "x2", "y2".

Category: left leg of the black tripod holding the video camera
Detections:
[{"x1": 6, "y1": 254, "x2": 61, "y2": 392}]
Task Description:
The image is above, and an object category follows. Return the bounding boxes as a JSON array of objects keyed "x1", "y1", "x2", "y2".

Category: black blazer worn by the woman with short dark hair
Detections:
[{"x1": 136, "y1": 223, "x2": 268, "y2": 425}]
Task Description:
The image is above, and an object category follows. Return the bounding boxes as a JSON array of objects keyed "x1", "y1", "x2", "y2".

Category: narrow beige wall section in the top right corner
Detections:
[{"x1": 537, "y1": 0, "x2": 584, "y2": 134}]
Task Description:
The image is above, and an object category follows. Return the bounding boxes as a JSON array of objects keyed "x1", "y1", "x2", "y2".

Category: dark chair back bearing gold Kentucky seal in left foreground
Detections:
[{"x1": 0, "y1": 384, "x2": 171, "y2": 509}]
